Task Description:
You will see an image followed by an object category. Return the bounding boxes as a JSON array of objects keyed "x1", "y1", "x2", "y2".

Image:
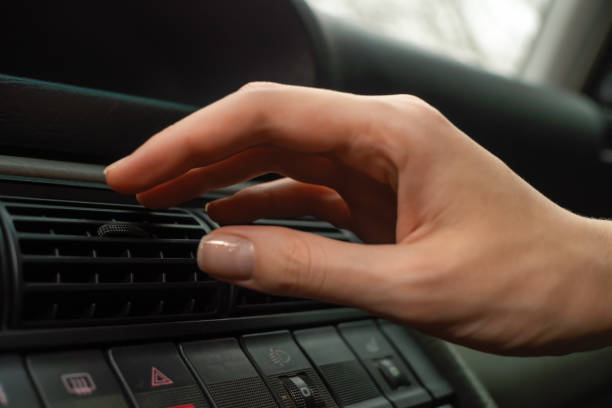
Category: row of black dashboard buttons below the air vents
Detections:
[{"x1": 0, "y1": 320, "x2": 453, "y2": 408}]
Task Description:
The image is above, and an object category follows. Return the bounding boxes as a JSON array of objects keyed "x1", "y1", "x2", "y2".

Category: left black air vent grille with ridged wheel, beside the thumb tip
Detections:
[{"x1": 0, "y1": 197, "x2": 228, "y2": 327}]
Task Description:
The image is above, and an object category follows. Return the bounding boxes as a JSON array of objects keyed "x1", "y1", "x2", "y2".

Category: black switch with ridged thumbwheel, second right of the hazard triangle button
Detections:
[{"x1": 242, "y1": 331, "x2": 337, "y2": 408}]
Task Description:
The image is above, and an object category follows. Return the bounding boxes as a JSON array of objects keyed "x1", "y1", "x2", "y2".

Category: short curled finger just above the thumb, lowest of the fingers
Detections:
[{"x1": 206, "y1": 178, "x2": 351, "y2": 228}]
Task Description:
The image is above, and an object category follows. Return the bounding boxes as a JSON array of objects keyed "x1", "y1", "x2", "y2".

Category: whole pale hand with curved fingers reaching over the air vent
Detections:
[{"x1": 106, "y1": 83, "x2": 612, "y2": 355}]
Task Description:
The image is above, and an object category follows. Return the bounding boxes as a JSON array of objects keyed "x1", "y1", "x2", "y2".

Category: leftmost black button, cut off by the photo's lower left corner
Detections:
[{"x1": 0, "y1": 355, "x2": 40, "y2": 408}]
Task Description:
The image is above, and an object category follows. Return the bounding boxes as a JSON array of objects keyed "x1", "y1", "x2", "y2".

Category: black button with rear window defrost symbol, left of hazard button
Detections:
[{"x1": 26, "y1": 350, "x2": 128, "y2": 408}]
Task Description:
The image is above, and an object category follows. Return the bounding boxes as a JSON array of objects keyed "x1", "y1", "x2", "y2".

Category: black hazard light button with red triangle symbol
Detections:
[{"x1": 109, "y1": 343, "x2": 210, "y2": 408}]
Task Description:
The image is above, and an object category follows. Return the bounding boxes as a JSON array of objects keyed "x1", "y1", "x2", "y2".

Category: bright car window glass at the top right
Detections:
[{"x1": 308, "y1": 0, "x2": 551, "y2": 77}]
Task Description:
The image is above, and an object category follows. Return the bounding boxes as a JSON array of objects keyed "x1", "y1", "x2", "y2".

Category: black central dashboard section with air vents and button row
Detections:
[{"x1": 0, "y1": 170, "x2": 482, "y2": 408}]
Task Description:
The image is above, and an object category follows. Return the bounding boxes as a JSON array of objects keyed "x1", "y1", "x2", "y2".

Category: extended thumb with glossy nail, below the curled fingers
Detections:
[{"x1": 198, "y1": 226, "x2": 400, "y2": 312}]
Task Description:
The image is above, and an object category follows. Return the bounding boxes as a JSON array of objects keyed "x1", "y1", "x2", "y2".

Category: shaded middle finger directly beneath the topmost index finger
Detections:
[{"x1": 137, "y1": 146, "x2": 350, "y2": 208}]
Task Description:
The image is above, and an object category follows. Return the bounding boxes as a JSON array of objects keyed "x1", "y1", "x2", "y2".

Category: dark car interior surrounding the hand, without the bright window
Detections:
[{"x1": 0, "y1": 0, "x2": 612, "y2": 408}]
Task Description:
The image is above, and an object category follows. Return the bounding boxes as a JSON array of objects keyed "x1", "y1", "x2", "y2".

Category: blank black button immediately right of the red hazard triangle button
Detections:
[{"x1": 180, "y1": 338, "x2": 278, "y2": 408}]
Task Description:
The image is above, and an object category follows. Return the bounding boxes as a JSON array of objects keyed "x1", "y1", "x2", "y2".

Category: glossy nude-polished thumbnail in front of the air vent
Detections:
[{"x1": 198, "y1": 233, "x2": 255, "y2": 280}]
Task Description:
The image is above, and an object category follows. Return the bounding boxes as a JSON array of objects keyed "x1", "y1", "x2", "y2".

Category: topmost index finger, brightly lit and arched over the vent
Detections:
[{"x1": 106, "y1": 85, "x2": 398, "y2": 193}]
